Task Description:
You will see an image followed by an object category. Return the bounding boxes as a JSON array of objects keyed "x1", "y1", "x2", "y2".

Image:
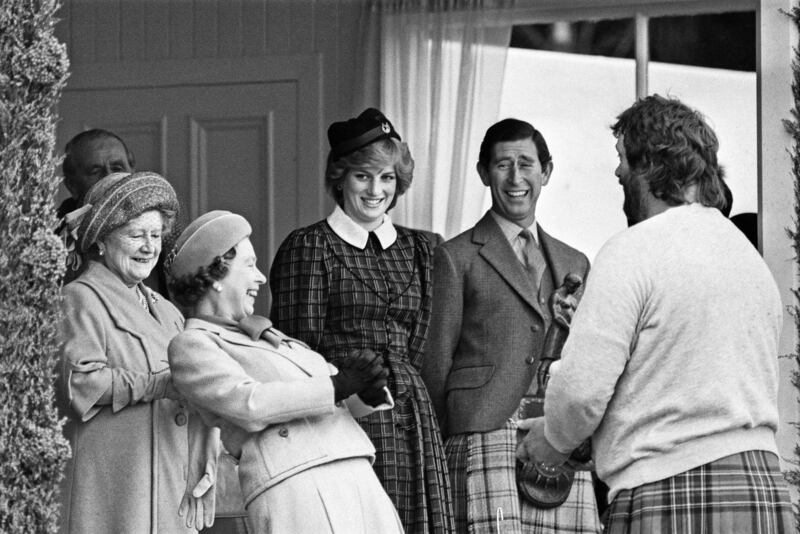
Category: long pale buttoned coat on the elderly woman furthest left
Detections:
[{"x1": 56, "y1": 261, "x2": 195, "y2": 534}]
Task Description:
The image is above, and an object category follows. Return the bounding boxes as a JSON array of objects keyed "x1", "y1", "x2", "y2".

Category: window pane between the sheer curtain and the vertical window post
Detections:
[{"x1": 504, "y1": 19, "x2": 636, "y2": 259}]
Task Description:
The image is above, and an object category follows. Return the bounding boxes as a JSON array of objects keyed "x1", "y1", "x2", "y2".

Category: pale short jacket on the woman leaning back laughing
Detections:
[{"x1": 169, "y1": 318, "x2": 393, "y2": 505}]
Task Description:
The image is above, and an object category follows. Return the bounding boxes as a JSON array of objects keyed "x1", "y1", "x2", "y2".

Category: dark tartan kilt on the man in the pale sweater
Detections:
[{"x1": 606, "y1": 451, "x2": 797, "y2": 534}]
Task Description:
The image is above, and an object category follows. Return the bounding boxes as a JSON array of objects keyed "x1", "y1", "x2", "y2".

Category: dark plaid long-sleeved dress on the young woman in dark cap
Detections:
[{"x1": 270, "y1": 220, "x2": 452, "y2": 533}]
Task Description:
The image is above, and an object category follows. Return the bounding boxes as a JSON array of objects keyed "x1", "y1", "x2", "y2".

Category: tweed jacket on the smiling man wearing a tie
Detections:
[{"x1": 422, "y1": 213, "x2": 589, "y2": 437}]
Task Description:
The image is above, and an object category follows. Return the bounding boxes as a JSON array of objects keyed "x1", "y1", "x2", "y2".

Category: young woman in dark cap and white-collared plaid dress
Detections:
[{"x1": 270, "y1": 109, "x2": 452, "y2": 533}]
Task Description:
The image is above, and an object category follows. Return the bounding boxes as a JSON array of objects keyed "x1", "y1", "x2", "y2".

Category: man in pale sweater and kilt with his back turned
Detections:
[{"x1": 517, "y1": 95, "x2": 795, "y2": 534}]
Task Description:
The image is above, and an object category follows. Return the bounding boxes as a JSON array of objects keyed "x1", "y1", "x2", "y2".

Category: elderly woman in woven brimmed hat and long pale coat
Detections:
[{"x1": 56, "y1": 172, "x2": 216, "y2": 534}]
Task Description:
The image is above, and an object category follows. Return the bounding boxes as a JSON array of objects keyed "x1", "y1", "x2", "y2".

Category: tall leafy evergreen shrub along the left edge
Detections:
[{"x1": 0, "y1": 0, "x2": 69, "y2": 534}]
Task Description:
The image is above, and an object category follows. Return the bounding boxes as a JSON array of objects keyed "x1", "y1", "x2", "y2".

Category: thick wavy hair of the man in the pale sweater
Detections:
[{"x1": 611, "y1": 94, "x2": 726, "y2": 210}]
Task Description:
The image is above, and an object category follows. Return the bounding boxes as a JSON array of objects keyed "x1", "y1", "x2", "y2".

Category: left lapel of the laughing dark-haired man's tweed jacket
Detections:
[{"x1": 472, "y1": 212, "x2": 545, "y2": 318}]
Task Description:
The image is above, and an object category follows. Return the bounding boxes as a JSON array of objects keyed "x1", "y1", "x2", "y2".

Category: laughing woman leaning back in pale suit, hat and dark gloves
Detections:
[{"x1": 167, "y1": 211, "x2": 402, "y2": 534}]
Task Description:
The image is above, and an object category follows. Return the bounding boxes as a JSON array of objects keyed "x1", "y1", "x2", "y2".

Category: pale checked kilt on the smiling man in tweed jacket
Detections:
[{"x1": 445, "y1": 423, "x2": 602, "y2": 534}]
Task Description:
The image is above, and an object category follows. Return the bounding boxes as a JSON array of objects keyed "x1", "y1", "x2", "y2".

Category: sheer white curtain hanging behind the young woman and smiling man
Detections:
[{"x1": 355, "y1": 0, "x2": 513, "y2": 238}]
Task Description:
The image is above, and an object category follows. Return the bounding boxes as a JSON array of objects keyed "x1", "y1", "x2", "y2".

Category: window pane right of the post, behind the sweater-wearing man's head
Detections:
[{"x1": 648, "y1": 12, "x2": 758, "y2": 215}]
